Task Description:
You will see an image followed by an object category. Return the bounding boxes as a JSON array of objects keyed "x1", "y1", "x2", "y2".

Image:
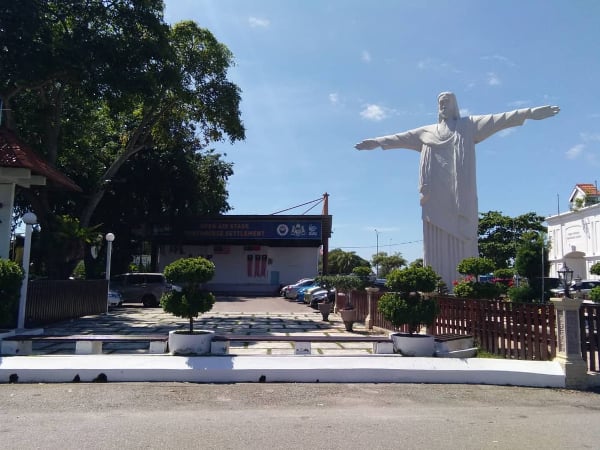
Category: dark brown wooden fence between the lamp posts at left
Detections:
[{"x1": 25, "y1": 280, "x2": 108, "y2": 328}]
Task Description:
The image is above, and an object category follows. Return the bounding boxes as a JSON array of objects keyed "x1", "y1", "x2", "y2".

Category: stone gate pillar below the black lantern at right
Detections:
[{"x1": 550, "y1": 297, "x2": 588, "y2": 389}]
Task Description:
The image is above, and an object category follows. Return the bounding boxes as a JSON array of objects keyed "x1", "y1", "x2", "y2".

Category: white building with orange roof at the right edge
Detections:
[{"x1": 546, "y1": 184, "x2": 600, "y2": 280}]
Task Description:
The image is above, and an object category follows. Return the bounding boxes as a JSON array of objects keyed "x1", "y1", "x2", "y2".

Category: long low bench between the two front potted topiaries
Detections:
[{"x1": 210, "y1": 334, "x2": 394, "y2": 355}]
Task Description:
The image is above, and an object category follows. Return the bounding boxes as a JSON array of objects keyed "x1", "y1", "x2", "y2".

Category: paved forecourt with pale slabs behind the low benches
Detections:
[{"x1": 33, "y1": 297, "x2": 385, "y2": 356}]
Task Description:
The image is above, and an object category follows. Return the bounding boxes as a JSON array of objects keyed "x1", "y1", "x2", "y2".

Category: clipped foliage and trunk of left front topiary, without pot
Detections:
[{"x1": 160, "y1": 257, "x2": 215, "y2": 334}]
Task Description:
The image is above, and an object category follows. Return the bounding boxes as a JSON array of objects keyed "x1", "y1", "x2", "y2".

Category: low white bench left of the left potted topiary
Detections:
[{"x1": 1, "y1": 334, "x2": 169, "y2": 355}]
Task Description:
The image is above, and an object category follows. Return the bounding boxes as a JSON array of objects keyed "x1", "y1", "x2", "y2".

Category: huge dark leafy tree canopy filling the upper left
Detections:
[{"x1": 0, "y1": 0, "x2": 245, "y2": 278}]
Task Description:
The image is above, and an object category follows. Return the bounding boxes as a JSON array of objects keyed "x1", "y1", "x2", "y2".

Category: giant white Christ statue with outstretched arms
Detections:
[{"x1": 355, "y1": 92, "x2": 560, "y2": 290}]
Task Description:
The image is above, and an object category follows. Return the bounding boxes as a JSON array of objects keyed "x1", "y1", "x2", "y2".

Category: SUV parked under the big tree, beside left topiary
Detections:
[{"x1": 110, "y1": 273, "x2": 172, "y2": 307}]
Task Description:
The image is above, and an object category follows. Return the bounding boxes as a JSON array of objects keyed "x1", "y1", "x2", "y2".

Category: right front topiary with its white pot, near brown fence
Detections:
[{"x1": 377, "y1": 266, "x2": 439, "y2": 356}]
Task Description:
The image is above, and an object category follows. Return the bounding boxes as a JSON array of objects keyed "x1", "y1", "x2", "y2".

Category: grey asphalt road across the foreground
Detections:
[{"x1": 0, "y1": 383, "x2": 600, "y2": 450}]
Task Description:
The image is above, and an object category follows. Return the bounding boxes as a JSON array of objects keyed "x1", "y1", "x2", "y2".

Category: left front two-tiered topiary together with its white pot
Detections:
[{"x1": 160, "y1": 257, "x2": 215, "y2": 355}]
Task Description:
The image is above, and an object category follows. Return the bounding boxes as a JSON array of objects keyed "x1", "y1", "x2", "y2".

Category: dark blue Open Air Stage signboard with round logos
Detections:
[{"x1": 185, "y1": 220, "x2": 322, "y2": 240}]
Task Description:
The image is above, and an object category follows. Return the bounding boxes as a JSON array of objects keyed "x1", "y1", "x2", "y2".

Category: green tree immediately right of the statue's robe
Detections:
[{"x1": 479, "y1": 211, "x2": 547, "y2": 269}]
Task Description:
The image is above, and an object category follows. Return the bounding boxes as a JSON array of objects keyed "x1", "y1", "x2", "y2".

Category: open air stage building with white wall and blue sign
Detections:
[{"x1": 147, "y1": 215, "x2": 332, "y2": 295}]
